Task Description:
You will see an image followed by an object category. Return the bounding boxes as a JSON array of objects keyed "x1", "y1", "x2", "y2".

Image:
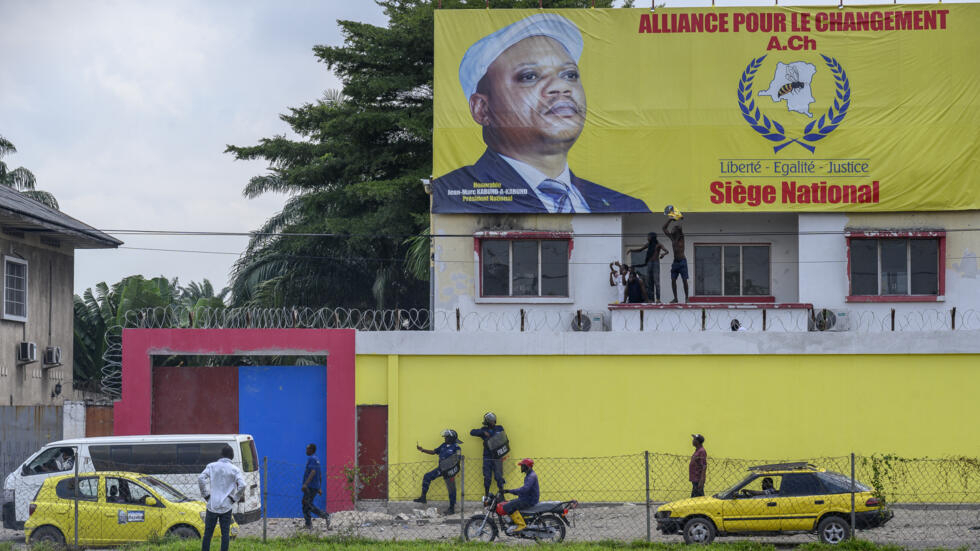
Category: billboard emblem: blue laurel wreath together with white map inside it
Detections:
[{"x1": 737, "y1": 54, "x2": 851, "y2": 153}]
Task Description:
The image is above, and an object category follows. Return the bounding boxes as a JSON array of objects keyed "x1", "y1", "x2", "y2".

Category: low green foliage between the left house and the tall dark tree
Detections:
[{"x1": 73, "y1": 275, "x2": 229, "y2": 389}]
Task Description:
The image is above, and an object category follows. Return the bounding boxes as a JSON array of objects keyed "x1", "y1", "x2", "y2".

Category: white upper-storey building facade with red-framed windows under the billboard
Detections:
[{"x1": 432, "y1": 211, "x2": 980, "y2": 332}]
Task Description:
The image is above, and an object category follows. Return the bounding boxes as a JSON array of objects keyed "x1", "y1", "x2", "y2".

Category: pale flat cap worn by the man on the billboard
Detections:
[{"x1": 459, "y1": 13, "x2": 582, "y2": 101}]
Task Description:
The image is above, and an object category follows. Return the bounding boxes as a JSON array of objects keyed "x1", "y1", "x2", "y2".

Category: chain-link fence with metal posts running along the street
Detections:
[{"x1": 2, "y1": 452, "x2": 980, "y2": 549}]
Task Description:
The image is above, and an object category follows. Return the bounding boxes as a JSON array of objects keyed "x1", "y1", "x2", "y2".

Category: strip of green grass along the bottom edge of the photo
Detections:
[{"x1": 115, "y1": 535, "x2": 964, "y2": 551}]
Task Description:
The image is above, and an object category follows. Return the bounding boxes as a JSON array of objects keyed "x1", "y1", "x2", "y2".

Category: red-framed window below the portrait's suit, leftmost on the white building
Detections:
[{"x1": 480, "y1": 239, "x2": 569, "y2": 297}]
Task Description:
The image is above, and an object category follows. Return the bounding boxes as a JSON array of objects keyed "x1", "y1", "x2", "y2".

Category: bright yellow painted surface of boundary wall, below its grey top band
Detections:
[{"x1": 357, "y1": 355, "x2": 980, "y2": 501}]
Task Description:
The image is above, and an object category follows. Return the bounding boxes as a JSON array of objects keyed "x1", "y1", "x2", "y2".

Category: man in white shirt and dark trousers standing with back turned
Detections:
[{"x1": 197, "y1": 444, "x2": 245, "y2": 551}]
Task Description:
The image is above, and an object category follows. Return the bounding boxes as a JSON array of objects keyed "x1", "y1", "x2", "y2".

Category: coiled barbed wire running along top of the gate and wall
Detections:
[{"x1": 102, "y1": 305, "x2": 980, "y2": 397}]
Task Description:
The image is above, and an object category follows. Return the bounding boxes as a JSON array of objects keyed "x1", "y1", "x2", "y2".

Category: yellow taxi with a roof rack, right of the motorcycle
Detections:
[{"x1": 654, "y1": 463, "x2": 893, "y2": 544}]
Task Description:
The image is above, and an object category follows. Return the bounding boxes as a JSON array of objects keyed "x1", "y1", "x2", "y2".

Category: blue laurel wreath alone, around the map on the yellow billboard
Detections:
[{"x1": 738, "y1": 54, "x2": 851, "y2": 153}]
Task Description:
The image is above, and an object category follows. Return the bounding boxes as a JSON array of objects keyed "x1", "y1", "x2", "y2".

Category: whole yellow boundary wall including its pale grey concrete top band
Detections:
[{"x1": 356, "y1": 331, "x2": 980, "y2": 500}]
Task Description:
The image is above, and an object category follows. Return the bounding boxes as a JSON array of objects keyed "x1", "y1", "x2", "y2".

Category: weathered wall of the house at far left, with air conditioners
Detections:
[{"x1": 0, "y1": 233, "x2": 74, "y2": 405}]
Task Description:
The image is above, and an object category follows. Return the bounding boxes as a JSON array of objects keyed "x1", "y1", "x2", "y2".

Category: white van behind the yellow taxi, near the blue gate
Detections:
[{"x1": 2, "y1": 434, "x2": 262, "y2": 530}]
